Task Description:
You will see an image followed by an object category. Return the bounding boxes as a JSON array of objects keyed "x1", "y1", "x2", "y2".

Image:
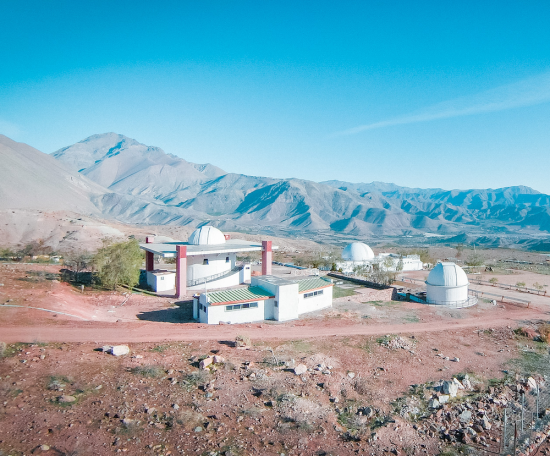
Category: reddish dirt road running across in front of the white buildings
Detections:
[{"x1": 0, "y1": 308, "x2": 549, "y2": 343}]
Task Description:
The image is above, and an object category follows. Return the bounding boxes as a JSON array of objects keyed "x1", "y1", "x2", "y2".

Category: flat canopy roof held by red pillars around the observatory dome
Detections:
[{"x1": 139, "y1": 239, "x2": 278, "y2": 258}]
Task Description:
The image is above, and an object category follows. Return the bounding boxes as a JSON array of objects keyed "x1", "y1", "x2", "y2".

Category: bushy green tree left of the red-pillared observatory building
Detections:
[{"x1": 93, "y1": 239, "x2": 143, "y2": 290}]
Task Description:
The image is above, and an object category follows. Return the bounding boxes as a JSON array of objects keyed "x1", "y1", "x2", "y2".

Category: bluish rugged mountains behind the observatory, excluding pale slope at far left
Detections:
[{"x1": 48, "y1": 133, "x2": 550, "y2": 236}]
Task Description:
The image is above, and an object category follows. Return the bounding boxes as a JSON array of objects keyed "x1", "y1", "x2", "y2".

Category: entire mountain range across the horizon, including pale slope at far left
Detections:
[{"x1": 0, "y1": 133, "x2": 550, "y2": 246}]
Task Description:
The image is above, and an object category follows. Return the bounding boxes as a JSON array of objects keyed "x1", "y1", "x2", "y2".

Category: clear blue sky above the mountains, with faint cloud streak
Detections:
[{"x1": 0, "y1": 0, "x2": 550, "y2": 193}]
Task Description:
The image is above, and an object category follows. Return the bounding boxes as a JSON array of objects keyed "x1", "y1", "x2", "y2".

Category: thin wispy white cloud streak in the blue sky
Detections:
[{"x1": 336, "y1": 72, "x2": 550, "y2": 135}]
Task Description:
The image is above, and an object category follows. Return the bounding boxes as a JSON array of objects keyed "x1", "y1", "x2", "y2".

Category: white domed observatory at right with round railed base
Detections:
[{"x1": 426, "y1": 262, "x2": 477, "y2": 307}]
